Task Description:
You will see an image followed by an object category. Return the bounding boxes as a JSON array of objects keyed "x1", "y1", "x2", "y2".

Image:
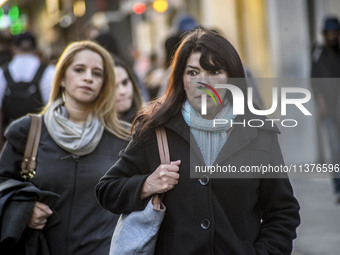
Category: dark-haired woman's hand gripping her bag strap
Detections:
[{"x1": 140, "y1": 160, "x2": 181, "y2": 199}]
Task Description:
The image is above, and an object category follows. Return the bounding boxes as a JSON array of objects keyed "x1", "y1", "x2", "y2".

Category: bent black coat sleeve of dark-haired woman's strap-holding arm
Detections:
[{"x1": 96, "y1": 132, "x2": 154, "y2": 214}]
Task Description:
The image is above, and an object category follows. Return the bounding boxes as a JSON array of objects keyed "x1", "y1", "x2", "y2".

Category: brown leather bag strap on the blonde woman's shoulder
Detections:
[{"x1": 20, "y1": 114, "x2": 42, "y2": 180}]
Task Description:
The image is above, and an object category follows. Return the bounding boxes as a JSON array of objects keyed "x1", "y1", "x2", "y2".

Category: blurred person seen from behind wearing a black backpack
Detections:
[{"x1": 0, "y1": 32, "x2": 54, "y2": 148}]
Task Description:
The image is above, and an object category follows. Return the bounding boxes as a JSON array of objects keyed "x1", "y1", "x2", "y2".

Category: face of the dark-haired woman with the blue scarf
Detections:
[{"x1": 183, "y1": 52, "x2": 228, "y2": 119}]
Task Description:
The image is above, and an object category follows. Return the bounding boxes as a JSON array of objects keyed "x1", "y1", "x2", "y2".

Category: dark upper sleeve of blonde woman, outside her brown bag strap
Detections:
[{"x1": 0, "y1": 116, "x2": 31, "y2": 182}]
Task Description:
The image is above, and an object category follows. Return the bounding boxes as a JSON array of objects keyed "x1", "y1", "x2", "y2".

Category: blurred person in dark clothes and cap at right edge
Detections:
[{"x1": 311, "y1": 17, "x2": 340, "y2": 204}]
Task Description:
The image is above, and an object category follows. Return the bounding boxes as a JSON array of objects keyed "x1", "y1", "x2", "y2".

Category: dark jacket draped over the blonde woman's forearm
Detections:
[{"x1": 0, "y1": 179, "x2": 60, "y2": 255}]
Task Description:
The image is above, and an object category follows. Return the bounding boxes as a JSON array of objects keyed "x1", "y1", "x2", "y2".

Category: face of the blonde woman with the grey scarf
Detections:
[{"x1": 61, "y1": 49, "x2": 104, "y2": 105}]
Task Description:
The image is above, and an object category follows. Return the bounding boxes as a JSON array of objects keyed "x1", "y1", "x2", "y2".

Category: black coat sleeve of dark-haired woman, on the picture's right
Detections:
[{"x1": 255, "y1": 135, "x2": 300, "y2": 255}]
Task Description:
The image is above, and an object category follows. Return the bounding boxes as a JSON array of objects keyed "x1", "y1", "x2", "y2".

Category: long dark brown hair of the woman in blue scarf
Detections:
[{"x1": 133, "y1": 28, "x2": 247, "y2": 138}]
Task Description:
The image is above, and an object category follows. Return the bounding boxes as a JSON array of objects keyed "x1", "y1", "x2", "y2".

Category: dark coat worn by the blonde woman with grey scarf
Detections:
[{"x1": 0, "y1": 117, "x2": 127, "y2": 255}]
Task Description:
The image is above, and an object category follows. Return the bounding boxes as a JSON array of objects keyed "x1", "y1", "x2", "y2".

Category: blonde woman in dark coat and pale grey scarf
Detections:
[{"x1": 0, "y1": 41, "x2": 130, "y2": 255}]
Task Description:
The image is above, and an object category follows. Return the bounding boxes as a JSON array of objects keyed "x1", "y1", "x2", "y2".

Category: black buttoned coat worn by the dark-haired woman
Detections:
[{"x1": 96, "y1": 111, "x2": 300, "y2": 255}]
